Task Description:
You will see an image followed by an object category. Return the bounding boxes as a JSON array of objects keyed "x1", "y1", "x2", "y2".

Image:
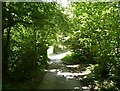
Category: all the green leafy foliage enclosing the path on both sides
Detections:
[{"x1": 2, "y1": 2, "x2": 120, "y2": 91}]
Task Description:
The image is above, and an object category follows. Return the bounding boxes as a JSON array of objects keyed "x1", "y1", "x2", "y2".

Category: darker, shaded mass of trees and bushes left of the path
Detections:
[{"x1": 2, "y1": 2, "x2": 68, "y2": 87}]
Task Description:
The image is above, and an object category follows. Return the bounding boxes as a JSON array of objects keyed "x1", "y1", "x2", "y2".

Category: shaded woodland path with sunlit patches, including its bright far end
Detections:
[{"x1": 38, "y1": 52, "x2": 90, "y2": 90}]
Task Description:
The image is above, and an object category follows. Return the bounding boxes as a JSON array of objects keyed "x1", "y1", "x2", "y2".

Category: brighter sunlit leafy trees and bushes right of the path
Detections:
[{"x1": 63, "y1": 2, "x2": 120, "y2": 89}]
